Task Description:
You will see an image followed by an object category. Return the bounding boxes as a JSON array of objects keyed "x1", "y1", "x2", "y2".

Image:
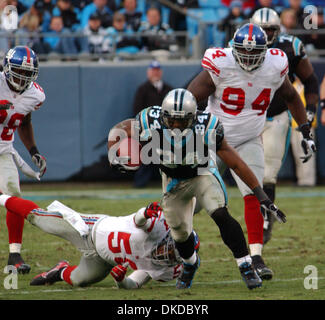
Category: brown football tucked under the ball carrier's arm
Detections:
[{"x1": 117, "y1": 138, "x2": 141, "y2": 167}]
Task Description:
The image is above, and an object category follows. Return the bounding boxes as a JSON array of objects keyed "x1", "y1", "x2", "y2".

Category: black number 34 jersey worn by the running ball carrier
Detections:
[{"x1": 136, "y1": 106, "x2": 224, "y2": 179}]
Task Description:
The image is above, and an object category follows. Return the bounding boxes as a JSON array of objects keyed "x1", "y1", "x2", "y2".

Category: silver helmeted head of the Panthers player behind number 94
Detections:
[{"x1": 251, "y1": 8, "x2": 281, "y2": 47}]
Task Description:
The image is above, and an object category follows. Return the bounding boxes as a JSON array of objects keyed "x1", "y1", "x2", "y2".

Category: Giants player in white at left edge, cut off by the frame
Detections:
[{"x1": 0, "y1": 46, "x2": 46, "y2": 273}]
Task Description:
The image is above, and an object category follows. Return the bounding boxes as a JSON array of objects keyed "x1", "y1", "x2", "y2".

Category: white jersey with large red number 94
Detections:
[{"x1": 202, "y1": 48, "x2": 288, "y2": 147}]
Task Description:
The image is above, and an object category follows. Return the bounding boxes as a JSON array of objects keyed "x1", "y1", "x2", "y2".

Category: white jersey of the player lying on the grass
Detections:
[{"x1": 92, "y1": 208, "x2": 183, "y2": 281}]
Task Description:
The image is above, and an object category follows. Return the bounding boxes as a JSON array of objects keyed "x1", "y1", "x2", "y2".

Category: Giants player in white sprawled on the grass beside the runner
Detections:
[{"x1": 0, "y1": 194, "x2": 200, "y2": 289}]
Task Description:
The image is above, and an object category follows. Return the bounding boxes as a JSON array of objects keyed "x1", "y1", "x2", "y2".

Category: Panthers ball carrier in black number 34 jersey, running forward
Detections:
[{"x1": 108, "y1": 89, "x2": 286, "y2": 289}]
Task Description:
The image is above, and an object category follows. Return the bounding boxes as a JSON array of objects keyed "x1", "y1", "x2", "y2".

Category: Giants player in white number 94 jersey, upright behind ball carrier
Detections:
[{"x1": 188, "y1": 23, "x2": 316, "y2": 280}]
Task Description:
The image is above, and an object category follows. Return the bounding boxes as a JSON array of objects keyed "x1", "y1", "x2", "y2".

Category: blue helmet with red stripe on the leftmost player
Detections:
[{"x1": 3, "y1": 46, "x2": 38, "y2": 92}]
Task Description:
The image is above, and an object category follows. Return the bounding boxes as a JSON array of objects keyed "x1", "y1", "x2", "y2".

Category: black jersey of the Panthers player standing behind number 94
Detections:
[{"x1": 266, "y1": 34, "x2": 307, "y2": 117}]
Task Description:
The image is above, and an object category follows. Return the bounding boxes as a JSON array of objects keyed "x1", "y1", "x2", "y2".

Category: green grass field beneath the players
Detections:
[{"x1": 0, "y1": 184, "x2": 325, "y2": 300}]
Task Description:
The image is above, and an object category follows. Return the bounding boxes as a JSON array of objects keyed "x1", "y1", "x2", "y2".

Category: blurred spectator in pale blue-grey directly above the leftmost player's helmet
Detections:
[{"x1": 17, "y1": 5, "x2": 51, "y2": 56}]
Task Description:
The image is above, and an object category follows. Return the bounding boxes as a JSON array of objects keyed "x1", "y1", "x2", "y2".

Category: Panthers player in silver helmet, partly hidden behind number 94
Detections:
[{"x1": 251, "y1": 8, "x2": 319, "y2": 244}]
